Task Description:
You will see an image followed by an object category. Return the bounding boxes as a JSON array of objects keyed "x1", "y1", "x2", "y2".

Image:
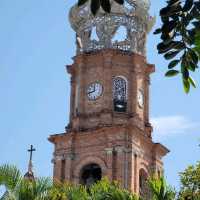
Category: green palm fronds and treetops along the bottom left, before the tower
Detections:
[{"x1": 0, "y1": 165, "x2": 139, "y2": 200}]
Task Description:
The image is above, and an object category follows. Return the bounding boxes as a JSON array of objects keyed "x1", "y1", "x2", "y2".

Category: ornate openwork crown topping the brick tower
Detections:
[{"x1": 69, "y1": 0, "x2": 155, "y2": 55}]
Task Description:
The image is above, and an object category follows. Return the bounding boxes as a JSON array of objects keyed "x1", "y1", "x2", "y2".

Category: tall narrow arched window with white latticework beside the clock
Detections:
[{"x1": 113, "y1": 76, "x2": 127, "y2": 112}]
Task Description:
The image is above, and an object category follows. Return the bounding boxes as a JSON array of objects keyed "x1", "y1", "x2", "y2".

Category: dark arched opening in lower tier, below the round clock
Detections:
[{"x1": 80, "y1": 163, "x2": 102, "y2": 187}]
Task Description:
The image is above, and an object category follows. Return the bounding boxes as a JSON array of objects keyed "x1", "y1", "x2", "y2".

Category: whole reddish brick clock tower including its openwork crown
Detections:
[{"x1": 49, "y1": 0, "x2": 169, "y2": 194}]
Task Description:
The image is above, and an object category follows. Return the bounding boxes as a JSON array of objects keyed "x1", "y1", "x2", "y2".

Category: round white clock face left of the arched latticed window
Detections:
[{"x1": 87, "y1": 82, "x2": 103, "y2": 100}]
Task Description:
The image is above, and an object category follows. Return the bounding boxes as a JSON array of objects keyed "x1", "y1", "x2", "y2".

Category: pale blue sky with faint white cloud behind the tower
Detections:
[{"x1": 0, "y1": 0, "x2": 200, "y2": 195}]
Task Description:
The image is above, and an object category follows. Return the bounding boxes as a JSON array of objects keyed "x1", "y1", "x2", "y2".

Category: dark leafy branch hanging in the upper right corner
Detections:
[{"x1": 154, "y1": 0, "x2": 200, "y2": 93}]
